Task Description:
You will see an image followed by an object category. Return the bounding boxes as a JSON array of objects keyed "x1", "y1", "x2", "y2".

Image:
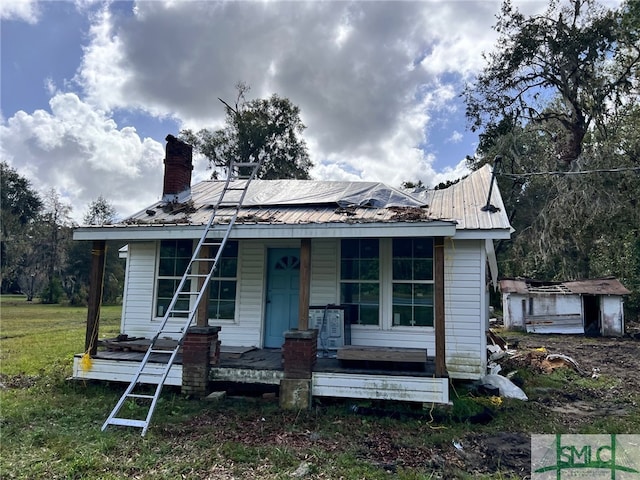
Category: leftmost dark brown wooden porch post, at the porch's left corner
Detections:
[{"x1": 84, "y1": 240, "x2": 107, "y2": 355}]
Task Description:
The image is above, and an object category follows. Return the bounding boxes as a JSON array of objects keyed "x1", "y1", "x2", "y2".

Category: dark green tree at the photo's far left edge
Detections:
[{"x1": 0, "y1": 162, "x2": 42, "y2": 292}]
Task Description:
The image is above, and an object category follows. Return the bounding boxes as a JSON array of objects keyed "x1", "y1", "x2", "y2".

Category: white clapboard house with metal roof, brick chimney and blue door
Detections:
[{"x1": 74, "y1": 136, "x2": 511, "y2": 402}]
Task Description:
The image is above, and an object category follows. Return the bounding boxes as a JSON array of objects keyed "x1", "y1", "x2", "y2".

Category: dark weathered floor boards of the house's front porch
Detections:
[{"x1": 94, "y1": 348, "x2": 435, "y2": 377}]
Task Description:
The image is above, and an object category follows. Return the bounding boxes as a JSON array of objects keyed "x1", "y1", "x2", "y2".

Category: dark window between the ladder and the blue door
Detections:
[{"x1": 208, "y1": 241, "x2": 238, "y2": 320}]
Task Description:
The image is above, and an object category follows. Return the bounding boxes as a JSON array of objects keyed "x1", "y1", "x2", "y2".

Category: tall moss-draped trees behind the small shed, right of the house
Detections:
[{"x1": 465, "y1": 0, "x2": 640, "y2": 318}]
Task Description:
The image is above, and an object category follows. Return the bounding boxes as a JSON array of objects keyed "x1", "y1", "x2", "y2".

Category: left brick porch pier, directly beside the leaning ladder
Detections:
[{"x1": 182, "y1": 326, "x2": 220, "y2": 398}]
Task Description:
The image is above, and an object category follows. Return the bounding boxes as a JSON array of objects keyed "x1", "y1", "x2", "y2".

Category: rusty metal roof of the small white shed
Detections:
[{"x1": 500, "y1": 277, "x2": 631, "y2": 295}]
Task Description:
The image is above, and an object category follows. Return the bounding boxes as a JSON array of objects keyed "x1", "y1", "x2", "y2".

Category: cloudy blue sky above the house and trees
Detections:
[{"x1": 0, "y1": 0, "x2": 546, "y2": 221}]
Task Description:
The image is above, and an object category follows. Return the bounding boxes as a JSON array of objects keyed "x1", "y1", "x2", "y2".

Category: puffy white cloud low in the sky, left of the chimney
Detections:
[{"x1": 0, "y1": 93, "x2": 164, "y2": 221}]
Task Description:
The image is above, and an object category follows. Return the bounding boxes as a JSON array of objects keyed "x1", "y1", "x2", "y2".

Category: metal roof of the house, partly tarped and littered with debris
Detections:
[{"x1": 80, "y1": 165, "x2": 511, "y2": 238}]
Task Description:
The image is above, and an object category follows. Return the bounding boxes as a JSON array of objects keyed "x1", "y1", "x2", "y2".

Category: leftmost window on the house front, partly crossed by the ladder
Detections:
[{"x1": 156, "y1": 240, "x2": 193, "y2": 317}]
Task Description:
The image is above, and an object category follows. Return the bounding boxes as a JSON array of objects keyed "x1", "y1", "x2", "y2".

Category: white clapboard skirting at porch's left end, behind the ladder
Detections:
[{"x1": 72, "y1": 355, "x2": 182, "y2": 386}]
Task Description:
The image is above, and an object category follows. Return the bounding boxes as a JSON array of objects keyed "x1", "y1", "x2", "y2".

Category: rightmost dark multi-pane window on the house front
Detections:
[{"x1": 392, "y1": 238, "x2": 433, "y2": 327}]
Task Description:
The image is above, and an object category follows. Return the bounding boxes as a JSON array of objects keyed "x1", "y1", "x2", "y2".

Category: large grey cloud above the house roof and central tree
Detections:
[{"x1": 71, "y1": 1, "x2": 510, "y2": 190}]
